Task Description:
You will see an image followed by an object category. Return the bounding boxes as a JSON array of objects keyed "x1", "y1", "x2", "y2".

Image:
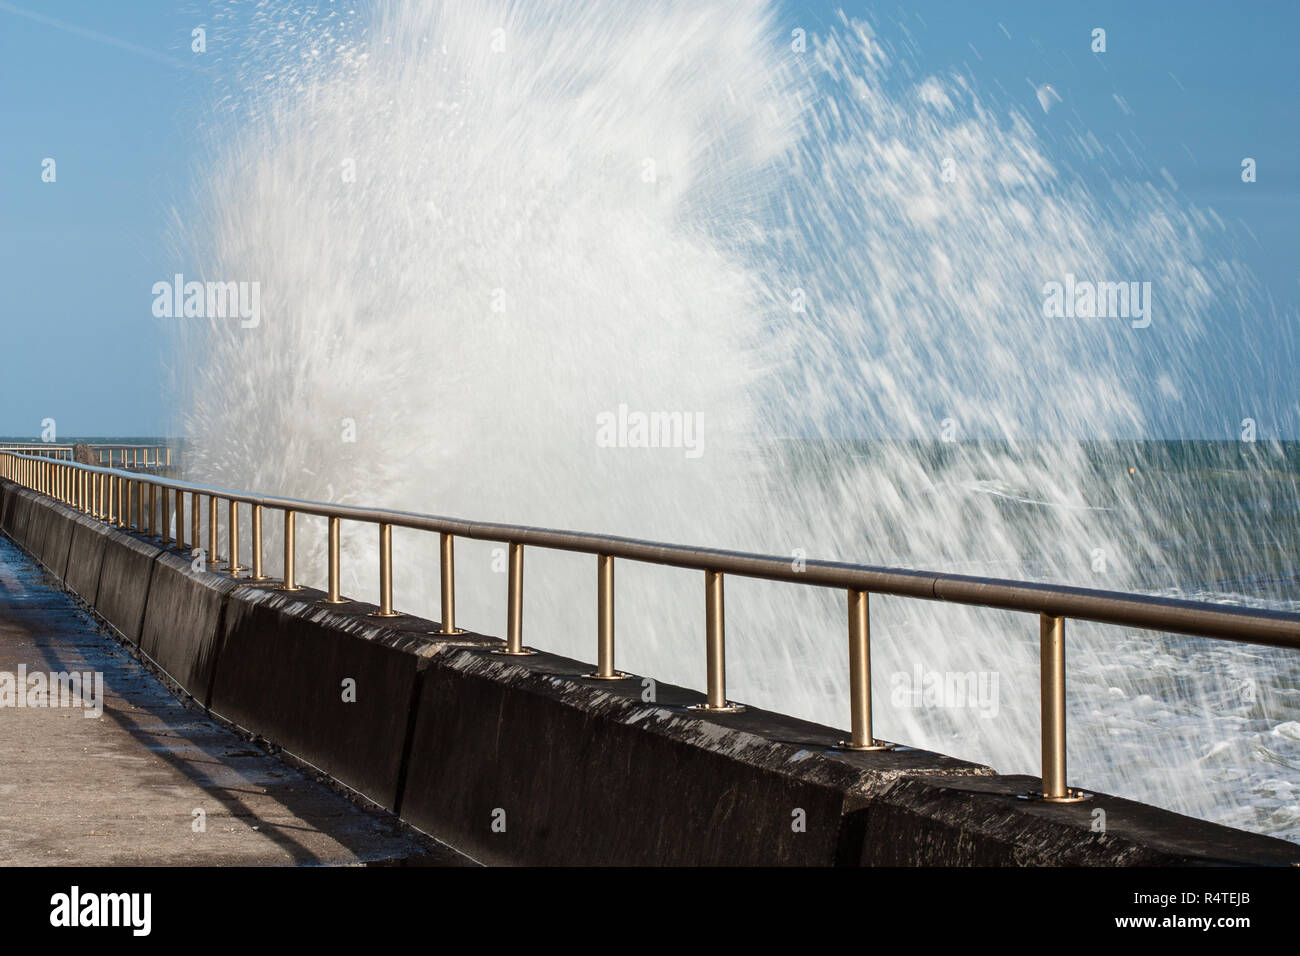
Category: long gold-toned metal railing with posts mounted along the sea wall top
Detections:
[{"x1": 0, "y1": 450, "x2": 1300, "y2": 803}]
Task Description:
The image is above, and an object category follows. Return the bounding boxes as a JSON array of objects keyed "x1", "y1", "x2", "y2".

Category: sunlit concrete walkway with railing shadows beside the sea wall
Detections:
[{"x1": 0, "y1": 536, "x2": 464, "y2": 866}]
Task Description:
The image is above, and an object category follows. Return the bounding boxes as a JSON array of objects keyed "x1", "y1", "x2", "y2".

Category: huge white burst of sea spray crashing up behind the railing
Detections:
[{"x1": 176, "y1": 0, "x2": 1300, "y2": 838}]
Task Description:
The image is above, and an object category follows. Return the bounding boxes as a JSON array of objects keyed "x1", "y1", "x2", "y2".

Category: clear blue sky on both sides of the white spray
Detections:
[{"x1": 0, "y1": 0, "x2": 1300, "y2": 437}]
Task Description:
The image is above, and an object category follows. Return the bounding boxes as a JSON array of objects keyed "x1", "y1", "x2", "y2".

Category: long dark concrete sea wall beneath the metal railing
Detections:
[{"x1": 0, "y1": 480, "x2": 1300, "y2": 866}]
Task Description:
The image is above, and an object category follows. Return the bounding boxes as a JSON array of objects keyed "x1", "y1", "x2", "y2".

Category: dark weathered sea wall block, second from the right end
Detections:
[{"x1": 402, "y1": 648, "x2": 993, "y2": 866}]
